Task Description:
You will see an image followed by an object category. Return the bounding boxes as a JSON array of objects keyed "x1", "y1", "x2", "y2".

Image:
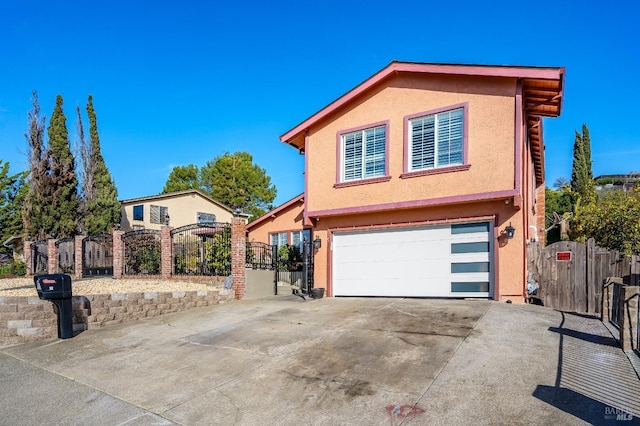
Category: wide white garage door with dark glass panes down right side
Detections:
[{"x1": 333, "y1": 222, "x2": 493, "y2": 297}]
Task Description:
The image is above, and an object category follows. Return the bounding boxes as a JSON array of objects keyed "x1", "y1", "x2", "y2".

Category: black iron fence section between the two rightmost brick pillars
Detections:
[{"x1": 171, "y1": 223, "x2": 231, "y2": 276}]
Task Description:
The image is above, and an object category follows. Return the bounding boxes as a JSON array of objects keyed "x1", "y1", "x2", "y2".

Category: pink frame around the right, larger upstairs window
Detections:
[{"x1": 400, "y1": 102, "x2": 471, "y2": 178}]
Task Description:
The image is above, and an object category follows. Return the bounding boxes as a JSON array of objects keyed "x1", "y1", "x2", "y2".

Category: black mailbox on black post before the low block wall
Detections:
[{"x1": 33, "y1": 274, "x2": 73, "y2": 339}]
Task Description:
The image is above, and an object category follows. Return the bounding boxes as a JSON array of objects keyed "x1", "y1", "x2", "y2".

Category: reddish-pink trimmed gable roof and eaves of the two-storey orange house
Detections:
[{"x1": 280, "y1": 61, "x2": 565, "y2": 185}]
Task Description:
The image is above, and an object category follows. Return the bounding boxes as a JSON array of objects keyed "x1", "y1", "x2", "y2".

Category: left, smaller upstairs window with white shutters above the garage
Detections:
[{"x1": 341, "y1": 126, "x2": 387, "y2": 182}]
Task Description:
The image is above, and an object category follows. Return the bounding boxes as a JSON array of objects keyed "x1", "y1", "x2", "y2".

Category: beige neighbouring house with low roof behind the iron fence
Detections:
[{"x1": 120, "y1": 189, "x2": 233, "y2": 231}]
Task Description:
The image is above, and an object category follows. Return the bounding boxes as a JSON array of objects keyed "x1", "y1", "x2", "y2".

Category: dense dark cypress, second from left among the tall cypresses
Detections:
[{"x1": 48, "y1": 95, "x2": 78, "y2": 238}]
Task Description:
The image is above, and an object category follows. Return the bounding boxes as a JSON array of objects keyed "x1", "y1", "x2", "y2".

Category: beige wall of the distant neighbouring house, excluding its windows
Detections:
[{"x1": 120, "y1": 190, "x2": 233, "y2": 231}]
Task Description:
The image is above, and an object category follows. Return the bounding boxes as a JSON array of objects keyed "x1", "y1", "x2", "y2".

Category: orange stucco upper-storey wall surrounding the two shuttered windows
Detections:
[{"x1": 306, "y1": 74, "x2": 516, "y2": 216}]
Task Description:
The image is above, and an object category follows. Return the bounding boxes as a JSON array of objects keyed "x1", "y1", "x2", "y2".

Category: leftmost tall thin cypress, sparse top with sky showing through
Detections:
[{"x1": 22, "y1": 91, "x2": 53, "y2": 241}]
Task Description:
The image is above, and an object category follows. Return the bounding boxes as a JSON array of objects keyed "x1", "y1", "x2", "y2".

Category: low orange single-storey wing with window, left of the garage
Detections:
[{"x1": 246, "y1": 194, "x2": 311, "y2": 251}]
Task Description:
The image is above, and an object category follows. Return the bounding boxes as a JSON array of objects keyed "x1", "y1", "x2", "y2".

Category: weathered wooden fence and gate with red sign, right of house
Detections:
[{"x1": 527, "y1": 239, "x2": 640, "y2": 314}]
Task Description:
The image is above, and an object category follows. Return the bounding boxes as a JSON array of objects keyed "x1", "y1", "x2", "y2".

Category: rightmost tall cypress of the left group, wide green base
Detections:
[{"x1": 83, "y1": 95, "x2": 120, "y2": 235}]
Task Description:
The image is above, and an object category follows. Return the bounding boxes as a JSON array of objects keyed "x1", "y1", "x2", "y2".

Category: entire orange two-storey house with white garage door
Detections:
[{"x1": 272, "y1": 62, "x2": 564, "y2": 302}]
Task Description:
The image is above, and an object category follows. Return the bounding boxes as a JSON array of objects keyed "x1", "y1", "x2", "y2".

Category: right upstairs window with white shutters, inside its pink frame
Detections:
[{"x1": 409, "y1": 108, "x2": 464, "y2": 171}]
